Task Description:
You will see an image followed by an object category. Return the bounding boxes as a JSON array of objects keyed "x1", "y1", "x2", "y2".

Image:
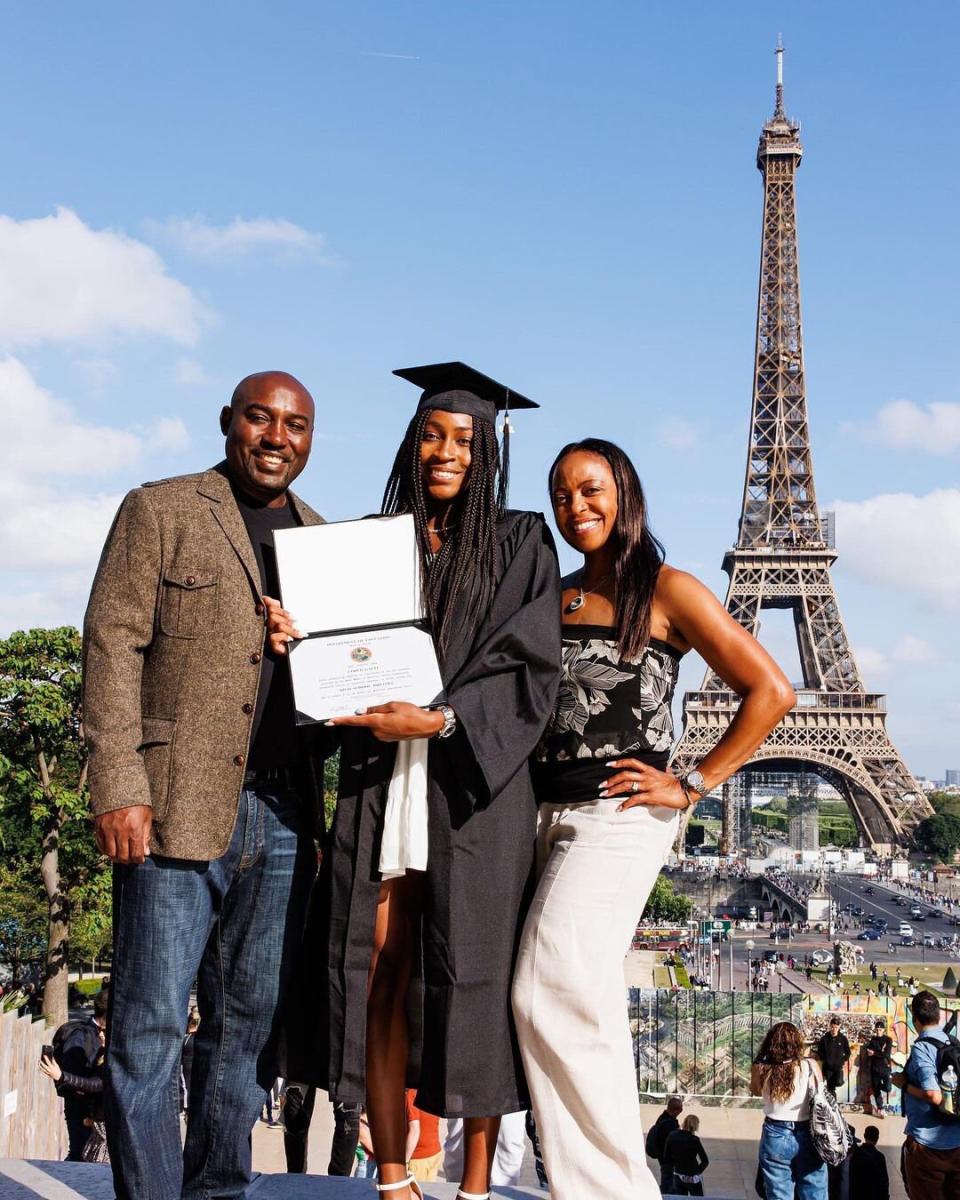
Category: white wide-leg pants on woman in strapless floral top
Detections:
[{"x1": 514, "y1": 798, "x2": 678, "y2": 1200}]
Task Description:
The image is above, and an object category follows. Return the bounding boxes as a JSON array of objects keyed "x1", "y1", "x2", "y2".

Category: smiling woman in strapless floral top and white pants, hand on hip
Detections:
[{"x1": 514, "y1": 438, "x2": 794, "y2": 1200}]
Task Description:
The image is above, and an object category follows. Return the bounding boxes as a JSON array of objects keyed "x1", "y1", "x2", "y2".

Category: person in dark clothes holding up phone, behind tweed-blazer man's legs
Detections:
[{"x1": 40, "y1": 991, "x2": 108, "y2": 1163}]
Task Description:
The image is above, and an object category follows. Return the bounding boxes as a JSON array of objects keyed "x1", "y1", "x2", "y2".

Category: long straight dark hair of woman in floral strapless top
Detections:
[{"x1": 547, "y1": 438, "x2": 664, "y2": 659}]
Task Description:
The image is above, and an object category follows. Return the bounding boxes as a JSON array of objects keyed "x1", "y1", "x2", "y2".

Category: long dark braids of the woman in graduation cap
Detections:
[{"x1": 380, "y1": 408, "x2": 508, "y2": 658}]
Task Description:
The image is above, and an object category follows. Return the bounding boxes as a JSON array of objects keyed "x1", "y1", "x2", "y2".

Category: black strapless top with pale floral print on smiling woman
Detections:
[{"x1": 534, "y1": 625, "x2": 683, "y2": 804}]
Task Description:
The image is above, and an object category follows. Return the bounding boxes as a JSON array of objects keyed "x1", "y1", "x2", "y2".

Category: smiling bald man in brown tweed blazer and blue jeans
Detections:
[{"x1": 84, "y1": 372, "x2": 322, "y2": 1200}]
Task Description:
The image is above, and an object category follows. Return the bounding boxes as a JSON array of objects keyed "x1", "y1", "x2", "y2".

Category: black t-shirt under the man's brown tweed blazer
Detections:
[{"x1": 233, "y1": 487, "x2": 301, "y2": 770}]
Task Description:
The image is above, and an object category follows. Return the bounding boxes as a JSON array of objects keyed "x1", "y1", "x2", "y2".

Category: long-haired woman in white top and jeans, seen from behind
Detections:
[{"x1": 750, "y1": 1021, "x2": 827, "y2": 1200}]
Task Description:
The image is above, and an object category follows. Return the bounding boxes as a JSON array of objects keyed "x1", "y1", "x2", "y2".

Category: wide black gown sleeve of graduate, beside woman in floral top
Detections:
[{"x1": 446, "y1": 512, "x2": 560, "y2": 805}]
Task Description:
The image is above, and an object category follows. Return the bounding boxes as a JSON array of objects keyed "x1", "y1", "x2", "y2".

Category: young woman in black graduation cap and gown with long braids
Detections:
[{"x1": 271, "y1": 364, "x2": 560, "y2": 1200}]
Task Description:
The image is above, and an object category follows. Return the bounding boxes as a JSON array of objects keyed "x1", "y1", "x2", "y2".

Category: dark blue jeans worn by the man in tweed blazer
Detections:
[{"x1": 104, "y1": 785, "x2": 317, "y2": 1200}]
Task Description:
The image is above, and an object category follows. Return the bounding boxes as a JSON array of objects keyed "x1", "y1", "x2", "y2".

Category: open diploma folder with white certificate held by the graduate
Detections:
[{"x1": 274, "y1": 514, "x2": 443, "y2": 725}]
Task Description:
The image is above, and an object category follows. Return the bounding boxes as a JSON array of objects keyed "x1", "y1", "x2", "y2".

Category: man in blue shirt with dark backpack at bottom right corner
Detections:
[{"x1": 892, "y1": 991, "x2": 960, "y2": 1200}]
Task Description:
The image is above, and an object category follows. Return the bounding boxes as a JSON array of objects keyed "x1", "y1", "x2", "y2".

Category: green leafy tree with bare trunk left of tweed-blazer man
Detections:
[{"x1": 0, "y1": 625, "x2": 106, "y2": 1024}]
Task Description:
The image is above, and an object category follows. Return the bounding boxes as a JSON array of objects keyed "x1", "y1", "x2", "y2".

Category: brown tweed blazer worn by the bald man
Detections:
[{"x1": 83, "y1": 463, "x2": 323, "y2": 862}]
